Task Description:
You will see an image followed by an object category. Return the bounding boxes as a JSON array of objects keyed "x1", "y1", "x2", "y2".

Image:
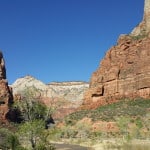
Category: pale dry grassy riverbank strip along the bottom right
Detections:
[{"x1": 54, "y1": 139, "x2": 150, "y2": 150}]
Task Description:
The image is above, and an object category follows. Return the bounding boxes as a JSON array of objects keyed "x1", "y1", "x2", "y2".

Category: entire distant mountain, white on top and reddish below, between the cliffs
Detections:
[{"x1": 11, "y1": 76, "x2": 89, "y2": 118}]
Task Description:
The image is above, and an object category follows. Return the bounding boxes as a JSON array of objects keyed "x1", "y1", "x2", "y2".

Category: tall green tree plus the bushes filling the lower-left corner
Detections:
[{"x1": 3, "y1": 88, "x2": 55, "y2": 150}]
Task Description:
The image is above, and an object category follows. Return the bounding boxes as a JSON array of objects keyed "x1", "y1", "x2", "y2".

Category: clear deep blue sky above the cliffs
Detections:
[{"x1": 0, "y1": 0, "x2": 144, "y2": 84}]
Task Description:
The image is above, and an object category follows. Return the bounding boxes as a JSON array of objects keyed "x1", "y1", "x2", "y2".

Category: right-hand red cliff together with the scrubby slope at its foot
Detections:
[{"x1": 53, "y1": 0, "x2": 150, "y2": 145}]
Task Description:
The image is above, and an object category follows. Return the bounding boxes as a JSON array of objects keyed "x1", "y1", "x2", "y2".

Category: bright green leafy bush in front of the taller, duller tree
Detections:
[{"x1": 18, "y1": 120, "x2": 54, "y2": 150}]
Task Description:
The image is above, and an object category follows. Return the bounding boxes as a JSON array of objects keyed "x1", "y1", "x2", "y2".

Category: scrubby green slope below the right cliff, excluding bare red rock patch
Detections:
[{"x1": 60, "y1": 98, "x2": 150, "y2": 141}]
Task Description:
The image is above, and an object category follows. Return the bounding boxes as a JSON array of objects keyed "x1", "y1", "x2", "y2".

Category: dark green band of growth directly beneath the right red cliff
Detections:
[{"x1": 65, "y1": 98, "x2": 150, "y2": 124}]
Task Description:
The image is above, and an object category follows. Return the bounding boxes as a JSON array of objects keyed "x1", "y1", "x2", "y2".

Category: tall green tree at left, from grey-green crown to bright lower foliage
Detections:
[{"x1": 14, "y1": 88, "x2": 54, "y2": 150}]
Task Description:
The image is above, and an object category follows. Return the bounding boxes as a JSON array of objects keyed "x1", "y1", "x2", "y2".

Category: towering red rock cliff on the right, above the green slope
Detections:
[{"x1": 83, "y1": 0, "x2": 150, "y2": 108}]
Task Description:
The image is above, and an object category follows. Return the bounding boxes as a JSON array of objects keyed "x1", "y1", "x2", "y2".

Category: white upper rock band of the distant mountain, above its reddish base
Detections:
[{"x1": 11, "y1": 76, "x2": 89, "y2": 105}]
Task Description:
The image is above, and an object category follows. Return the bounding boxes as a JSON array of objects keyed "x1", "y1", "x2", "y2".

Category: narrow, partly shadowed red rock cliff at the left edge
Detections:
[{"x1": 0, "y1": 52, "x2": 12, "y2": 122}]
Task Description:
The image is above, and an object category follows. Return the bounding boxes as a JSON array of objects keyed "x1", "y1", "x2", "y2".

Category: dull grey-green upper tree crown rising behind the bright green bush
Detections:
[{"x1": 14, "y1": 88, "x2": 50, "y2": 121}]
